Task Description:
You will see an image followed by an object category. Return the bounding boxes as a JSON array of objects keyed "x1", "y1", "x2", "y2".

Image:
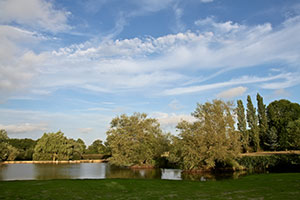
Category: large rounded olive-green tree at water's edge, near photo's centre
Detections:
[{"x1": 107, "y1": 113, "x2": 167, "y2": 166}]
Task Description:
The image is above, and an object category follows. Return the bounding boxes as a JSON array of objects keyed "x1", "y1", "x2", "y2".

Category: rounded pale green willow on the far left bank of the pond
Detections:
[{"x1": 33, "y1": 131, "x2": 74, "y2": 161}]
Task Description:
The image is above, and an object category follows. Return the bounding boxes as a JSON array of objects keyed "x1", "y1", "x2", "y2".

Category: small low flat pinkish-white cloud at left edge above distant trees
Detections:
[{"x1": 0, "y1": 123, "x2": 48, "y2": 133}]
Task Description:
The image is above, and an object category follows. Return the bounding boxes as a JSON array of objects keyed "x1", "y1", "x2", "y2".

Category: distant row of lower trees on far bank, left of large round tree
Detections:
[{"x1": 0, "y1": 130, "x2": 106, "y2": 161}]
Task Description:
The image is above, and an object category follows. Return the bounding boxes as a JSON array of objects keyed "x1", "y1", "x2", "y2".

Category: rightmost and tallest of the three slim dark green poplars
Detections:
[{"x1": 256, "y1": 93, "x2": 270, "y2": 148}]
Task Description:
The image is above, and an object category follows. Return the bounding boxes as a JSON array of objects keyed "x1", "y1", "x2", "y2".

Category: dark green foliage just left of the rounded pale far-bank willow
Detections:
[{"x1": 7, "y1": 138, "x2": 36, "y2": 160}]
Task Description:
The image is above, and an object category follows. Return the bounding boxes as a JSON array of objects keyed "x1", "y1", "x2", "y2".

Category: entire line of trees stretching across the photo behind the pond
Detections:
[{"x1": 0, "y1": 94, "x2": 300, "y2": 170}]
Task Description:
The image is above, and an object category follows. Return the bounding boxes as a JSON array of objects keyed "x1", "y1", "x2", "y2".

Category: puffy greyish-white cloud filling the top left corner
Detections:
[{"x1": 0, "y1": 0, "x2": 70, "y2": 32}]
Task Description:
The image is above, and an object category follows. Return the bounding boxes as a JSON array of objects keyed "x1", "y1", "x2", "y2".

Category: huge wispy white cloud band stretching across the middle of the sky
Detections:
[{"x1": 1, "y1": 13, "x2": 300, "y2": 99}]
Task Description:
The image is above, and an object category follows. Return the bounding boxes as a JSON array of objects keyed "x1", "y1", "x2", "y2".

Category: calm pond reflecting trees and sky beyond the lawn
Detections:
[{"x1": 0, "y1": 163, "x2": 244, "y2": 181}]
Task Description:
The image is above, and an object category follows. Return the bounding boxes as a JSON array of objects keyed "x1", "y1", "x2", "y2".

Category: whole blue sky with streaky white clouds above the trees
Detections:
[{"x1": 0, "y1": 0, "x2": 300, "y2": 144}]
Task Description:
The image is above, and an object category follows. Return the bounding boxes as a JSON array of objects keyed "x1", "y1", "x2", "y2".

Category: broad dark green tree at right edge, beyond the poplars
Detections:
[{"x1": 267, "y1": 99, "x2": 300, "y2": 150}]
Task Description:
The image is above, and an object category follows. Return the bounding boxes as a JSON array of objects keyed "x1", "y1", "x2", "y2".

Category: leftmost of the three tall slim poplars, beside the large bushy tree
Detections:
[{"x1": 236, "y1": 100, "x2": 249, "y2": 152}]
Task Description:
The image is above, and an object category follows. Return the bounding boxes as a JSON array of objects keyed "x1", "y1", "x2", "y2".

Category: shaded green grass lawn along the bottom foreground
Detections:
[{"x1": 0, "y1": 173, "x2": 300, "y2": 200}]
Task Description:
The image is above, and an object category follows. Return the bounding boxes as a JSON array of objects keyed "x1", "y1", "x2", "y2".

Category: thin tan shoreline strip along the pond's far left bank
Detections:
[{"x1": 0, "y1": 159, "x2": 107, "y2": 165}]
